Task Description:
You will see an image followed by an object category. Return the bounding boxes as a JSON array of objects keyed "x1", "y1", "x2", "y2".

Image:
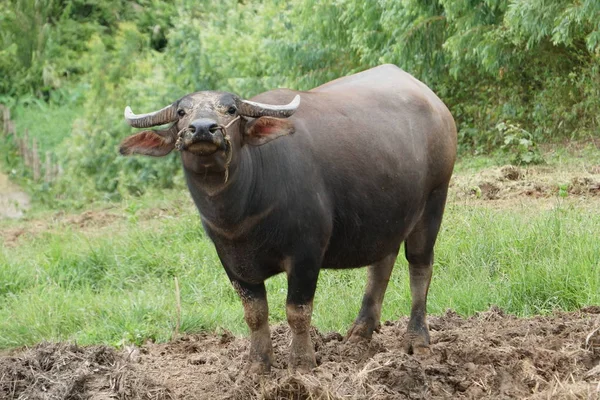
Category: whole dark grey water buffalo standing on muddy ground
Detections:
[{"x1": 120, "y1": 65, "x2": 456, "y2": 373}]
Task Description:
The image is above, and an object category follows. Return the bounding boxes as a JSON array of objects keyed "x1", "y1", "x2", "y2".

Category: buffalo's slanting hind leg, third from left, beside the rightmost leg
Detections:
[{"x1": 346, "y1": 250, "x2": 398, "y2": 342}]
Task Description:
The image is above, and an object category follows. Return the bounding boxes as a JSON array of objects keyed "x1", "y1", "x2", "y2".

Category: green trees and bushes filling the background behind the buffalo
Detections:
[{"x1": 0, "y1": 0, "x2": 600, "y2": 205}]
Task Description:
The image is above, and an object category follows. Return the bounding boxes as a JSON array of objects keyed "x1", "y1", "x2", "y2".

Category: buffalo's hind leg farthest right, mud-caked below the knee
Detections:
[{"x1": 405, "y1": 186, "x2": 448, "y2": 354}]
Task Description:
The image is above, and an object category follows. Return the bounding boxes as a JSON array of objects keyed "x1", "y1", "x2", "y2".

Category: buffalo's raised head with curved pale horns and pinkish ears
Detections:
[{"x1": 120, "y1": 91, "x2": 300, "y2": 176}]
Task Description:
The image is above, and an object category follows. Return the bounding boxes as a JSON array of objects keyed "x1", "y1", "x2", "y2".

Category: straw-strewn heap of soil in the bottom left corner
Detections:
[{"x1": 0, "y1": 343, "x2": 173, "y2": 400}]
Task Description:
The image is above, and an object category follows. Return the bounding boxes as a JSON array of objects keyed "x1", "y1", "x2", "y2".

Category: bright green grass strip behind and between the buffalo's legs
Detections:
[{"x1": 0, "y1": 191, "x2": 600, "y2": 348}]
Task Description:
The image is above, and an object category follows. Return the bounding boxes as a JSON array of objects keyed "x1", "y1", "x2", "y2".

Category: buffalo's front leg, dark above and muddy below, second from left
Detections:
[{"x1": 286, "y1": 263, "x2": 319, "y2": 372}]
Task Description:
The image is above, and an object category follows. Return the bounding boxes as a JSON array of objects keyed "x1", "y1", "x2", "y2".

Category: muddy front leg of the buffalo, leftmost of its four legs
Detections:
[{"x1": 231, "y1": 279, "x2": 273, "y2": 374}]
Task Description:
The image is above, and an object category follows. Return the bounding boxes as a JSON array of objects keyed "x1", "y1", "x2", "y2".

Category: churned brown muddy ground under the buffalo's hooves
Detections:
[{"x1": 0, "y1": 307, "x2": 600, "y2": 399}]
